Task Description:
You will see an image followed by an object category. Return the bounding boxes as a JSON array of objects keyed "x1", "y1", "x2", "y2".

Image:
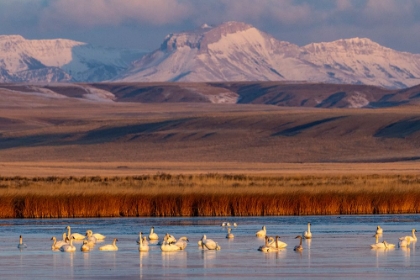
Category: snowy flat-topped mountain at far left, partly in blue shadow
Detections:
[{"x1": 0, "y1": 35, "x2": 144, "y2": 82}]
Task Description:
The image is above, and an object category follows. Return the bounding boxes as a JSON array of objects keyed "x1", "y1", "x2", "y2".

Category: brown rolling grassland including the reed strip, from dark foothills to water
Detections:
[{"x1": 0, "y1": 82, "x2": 420, "y2": 218}]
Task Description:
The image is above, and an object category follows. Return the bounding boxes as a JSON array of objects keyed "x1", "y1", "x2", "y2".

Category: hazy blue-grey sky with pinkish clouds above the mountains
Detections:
[{"x1": 0, "y1": 0, "x2": 420, "y2": 53}]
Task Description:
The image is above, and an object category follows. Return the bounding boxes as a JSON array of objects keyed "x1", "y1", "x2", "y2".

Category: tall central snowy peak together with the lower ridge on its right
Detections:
[{"x1": 114, "y1": 22, "x2": 420, "y2": 88}]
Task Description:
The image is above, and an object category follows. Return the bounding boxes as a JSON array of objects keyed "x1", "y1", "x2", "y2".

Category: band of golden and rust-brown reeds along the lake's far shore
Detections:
[{"x1": 0, "y1": 173, "x2": 420, "y2": 218}]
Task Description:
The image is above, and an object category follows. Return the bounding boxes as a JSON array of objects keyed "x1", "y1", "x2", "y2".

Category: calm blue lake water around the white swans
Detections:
[{"x1": 0, "y1": 215, "x2": 420, "y2": 279}]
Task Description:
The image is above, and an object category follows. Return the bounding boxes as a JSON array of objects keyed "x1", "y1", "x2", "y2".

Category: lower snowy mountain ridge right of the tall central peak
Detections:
[{"x1": 301, "y1": 38, "x2": 420, "y2": 88}]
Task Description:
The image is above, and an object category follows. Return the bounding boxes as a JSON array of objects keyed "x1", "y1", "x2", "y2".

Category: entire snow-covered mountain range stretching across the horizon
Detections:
[{"x1": 0, "y1": 21, "x2": 420, "y2": 89}]
